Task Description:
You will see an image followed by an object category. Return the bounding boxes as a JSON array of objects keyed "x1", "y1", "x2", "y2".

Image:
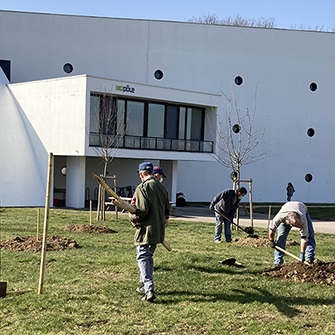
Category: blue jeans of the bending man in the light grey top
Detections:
[{"x1": 275, "y1": 212, "x2": 315, "y2": 265}]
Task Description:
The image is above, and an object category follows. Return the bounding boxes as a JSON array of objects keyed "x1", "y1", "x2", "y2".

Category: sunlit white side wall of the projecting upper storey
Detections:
[{"x1": 10, "y1": 76, "x2": 87, "y2": 155}]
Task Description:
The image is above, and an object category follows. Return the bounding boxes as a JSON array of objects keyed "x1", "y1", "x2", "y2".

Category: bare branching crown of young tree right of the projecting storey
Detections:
[{"x1": 215, "y1": 86, "x2": 268, "y2": 179}]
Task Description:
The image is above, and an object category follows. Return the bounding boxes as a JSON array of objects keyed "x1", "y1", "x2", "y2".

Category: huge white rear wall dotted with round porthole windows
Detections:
[{"x1": 0, "y1": 11, "x2": 335, "y2": 202}]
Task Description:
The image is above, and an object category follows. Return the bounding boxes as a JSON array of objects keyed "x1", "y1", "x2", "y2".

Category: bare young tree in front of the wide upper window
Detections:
[{"x1": 90, "y1": 93, "x2": 127, "y2": 220}]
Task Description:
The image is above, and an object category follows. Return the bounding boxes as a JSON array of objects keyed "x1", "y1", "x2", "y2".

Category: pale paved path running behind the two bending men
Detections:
[{"x1": 170, "y1": 206, "x2": 335, "y2": 234}]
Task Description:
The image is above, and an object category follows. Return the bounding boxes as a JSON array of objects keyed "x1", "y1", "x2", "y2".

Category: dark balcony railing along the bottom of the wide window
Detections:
[{"x1": 90, "y1": 133, "x2": 213, "y2": 153}]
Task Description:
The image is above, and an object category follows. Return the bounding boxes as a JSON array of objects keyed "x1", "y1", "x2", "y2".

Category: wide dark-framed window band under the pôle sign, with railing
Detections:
[{"x1": 90, "y1": 93, "x2": 213, "y2": 152}]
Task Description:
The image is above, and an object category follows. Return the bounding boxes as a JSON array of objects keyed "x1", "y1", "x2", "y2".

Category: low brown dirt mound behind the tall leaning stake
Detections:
[{"x1": 0, "y1": 236, "x2": 81, "y2": 252}]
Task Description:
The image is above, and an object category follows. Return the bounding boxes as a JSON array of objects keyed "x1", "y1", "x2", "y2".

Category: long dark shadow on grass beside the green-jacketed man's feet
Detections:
[{"x1": 156, "y1": 287, "x2": 335, "y2": 318}]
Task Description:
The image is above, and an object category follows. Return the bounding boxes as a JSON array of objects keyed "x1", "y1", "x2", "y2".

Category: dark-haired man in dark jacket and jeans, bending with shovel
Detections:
[{"x1": 209, "y1": 187, "x2": 247, "y2": 243}]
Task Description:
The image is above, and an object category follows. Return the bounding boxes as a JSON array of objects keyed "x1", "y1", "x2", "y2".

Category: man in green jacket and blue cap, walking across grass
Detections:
[{"x1": 129, "y1": 162, "x2": 170, "y2": 302}]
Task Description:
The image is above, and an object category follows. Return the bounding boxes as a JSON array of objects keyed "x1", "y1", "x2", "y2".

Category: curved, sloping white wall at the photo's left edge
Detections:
[{"x1": 0, "y1": 69, "x2": 48, "y2": 206}]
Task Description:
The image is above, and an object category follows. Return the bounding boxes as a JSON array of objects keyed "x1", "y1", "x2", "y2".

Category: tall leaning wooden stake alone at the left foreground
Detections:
[{"x1": 38, "y1": 152, "x2": 53, "y2": 294}]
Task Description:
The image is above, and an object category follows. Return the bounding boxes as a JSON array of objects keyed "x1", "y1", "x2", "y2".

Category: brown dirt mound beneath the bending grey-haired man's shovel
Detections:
[{"x1": 263, "y1": 260, "x2": 335, "y2": 286}]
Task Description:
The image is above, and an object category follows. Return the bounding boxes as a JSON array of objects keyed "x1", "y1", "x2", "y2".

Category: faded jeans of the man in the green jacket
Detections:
[{"x1": 136, "y1": 244, "x2": 156, "y2": 292}]
